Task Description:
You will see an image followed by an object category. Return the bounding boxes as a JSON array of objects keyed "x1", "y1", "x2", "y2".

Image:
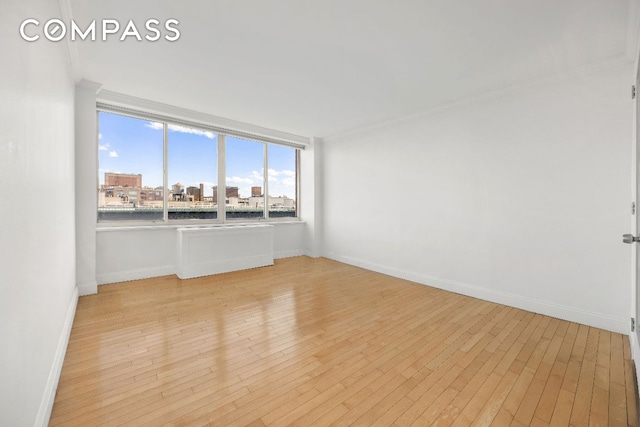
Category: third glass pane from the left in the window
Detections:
[{"x1": 225, "y1": 136, "x2": 264, "y2": 220}]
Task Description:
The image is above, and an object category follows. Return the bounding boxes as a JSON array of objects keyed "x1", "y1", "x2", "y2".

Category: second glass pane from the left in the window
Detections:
[{"x1": 167, "y1": 124, "x2": 218, "y2": 220}]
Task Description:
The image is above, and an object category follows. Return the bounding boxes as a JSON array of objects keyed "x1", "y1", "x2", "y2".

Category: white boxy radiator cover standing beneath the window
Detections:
[{"x1": 177, "y1": 224, "x2": 273, "y2": 279}]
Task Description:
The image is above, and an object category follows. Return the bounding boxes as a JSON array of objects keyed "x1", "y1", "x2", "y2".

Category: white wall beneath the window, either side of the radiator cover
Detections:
[{"x1": 96, "y1": 222, "x2": 306, "y2": 284}]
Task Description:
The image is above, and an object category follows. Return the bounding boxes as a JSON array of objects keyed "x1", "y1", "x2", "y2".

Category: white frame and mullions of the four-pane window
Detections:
[{"x1": 96, "y1": 102, "x2": 305, "y2": 228}]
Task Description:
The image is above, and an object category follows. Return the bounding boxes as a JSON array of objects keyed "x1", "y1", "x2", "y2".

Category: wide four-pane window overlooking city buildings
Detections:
[{"x1": 98, "y1": 111, "x2": 299, "y2": 222}]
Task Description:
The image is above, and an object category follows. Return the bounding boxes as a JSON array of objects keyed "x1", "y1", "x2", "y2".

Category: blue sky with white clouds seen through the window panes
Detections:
[{"x1": 98, "y1": 112, "x2": 295, "y2": 199}]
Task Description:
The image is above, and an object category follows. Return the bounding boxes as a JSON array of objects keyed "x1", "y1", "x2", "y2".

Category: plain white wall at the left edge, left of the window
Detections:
[{"x1": 0, "y1": 0, "x2": 77, "y2": 427}]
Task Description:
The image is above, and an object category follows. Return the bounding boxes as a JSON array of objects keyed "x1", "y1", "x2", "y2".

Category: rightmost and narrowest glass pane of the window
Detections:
[{"x1": 268, "y1": 144, "x2": 298, "y2": 218}]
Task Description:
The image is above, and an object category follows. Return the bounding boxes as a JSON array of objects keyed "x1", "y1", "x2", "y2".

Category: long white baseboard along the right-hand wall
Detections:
[{"x1": 324, "y1": 252, "x2": 629, "y2": 335}]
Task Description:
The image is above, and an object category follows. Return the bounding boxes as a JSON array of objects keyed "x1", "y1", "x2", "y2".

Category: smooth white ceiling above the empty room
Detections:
[{"x1": 68, "y1": 0, "x2": 638, "y2": 137}]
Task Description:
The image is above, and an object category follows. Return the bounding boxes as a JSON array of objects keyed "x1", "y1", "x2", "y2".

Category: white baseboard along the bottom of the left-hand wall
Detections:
[{"x1": 34, "y1": 287, "x2": 78, "y2": 426}]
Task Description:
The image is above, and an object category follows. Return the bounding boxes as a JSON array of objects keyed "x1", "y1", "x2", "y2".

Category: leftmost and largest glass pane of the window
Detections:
[{"x1": 98, "y1": 112, "x2": 164, "y2": 221}]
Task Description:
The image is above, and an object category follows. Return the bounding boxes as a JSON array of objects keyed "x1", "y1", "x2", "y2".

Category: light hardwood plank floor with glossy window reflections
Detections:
[{"x1": 50, "y1": 257, "x2": 636, "y2": 427}]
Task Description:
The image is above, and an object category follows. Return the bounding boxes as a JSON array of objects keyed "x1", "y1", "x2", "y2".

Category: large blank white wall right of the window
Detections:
[{"x1": 323, "y1": 64, "x2": 633, "y2": 333}]
